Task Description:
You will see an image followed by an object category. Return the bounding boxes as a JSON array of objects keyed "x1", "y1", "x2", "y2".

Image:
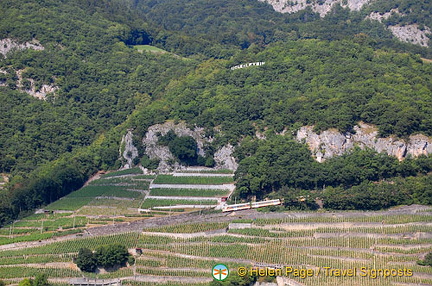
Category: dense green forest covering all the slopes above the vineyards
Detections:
[{"x1": 0, "y1": 0, "x2": 432, "y2": 225}]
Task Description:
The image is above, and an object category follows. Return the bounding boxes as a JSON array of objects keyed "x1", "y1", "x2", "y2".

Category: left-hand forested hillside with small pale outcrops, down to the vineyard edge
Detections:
[{"x1": 0, "y1": 0, "x2": 196, "y2": 226}]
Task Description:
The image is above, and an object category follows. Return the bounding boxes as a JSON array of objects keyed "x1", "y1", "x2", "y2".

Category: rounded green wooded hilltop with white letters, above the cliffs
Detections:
[{"x1": 130, "y1": 40, "x2": 432, "y2": 139}]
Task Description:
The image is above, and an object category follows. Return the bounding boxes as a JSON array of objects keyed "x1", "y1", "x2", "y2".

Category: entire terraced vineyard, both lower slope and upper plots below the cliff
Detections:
[{"x1": 0, "y1": 166, "x2": 432, "y2": 286}]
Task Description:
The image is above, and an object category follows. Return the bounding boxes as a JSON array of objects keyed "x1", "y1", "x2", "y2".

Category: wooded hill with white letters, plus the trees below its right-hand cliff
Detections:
[{"x1": 130, "y1": 40, "x2": 432, "y2": 209}]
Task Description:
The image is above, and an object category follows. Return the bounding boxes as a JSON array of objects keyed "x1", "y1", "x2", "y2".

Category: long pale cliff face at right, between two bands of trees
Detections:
[{"x1": 297, "y1": 123, "x2": 432, "y2": 162}]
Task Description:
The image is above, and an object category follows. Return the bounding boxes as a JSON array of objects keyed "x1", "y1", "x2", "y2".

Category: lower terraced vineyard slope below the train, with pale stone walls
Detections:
[{"x1": 0, "y1": 207, "x2": 432, "y2": 285}]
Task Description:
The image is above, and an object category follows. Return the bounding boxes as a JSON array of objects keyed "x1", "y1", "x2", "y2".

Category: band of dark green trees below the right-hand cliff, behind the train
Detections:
[{"x1": 235, "y1": 136, "x2": 432, "y2": 210}]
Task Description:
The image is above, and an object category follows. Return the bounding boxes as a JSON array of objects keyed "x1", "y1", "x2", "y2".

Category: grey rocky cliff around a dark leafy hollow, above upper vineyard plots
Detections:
[{"x1": 138, "y1": 121, "x2": 237, "y2": 172}]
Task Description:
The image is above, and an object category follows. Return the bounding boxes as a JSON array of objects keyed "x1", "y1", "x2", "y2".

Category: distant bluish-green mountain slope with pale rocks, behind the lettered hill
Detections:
[{"x1": 134, "y1": 0, "x2": 431, "y2": 57}]
